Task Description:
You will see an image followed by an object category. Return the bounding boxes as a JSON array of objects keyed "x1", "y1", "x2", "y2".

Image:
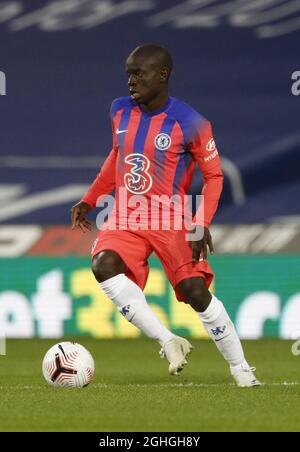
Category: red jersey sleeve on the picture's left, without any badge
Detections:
[{"x1": 81, "y1": 104, "x2": 118, "y2": 207}]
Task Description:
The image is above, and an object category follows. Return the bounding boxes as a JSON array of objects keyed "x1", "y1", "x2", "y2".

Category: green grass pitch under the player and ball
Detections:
[{"x1": 0, "y1": 337, "x2": 300, "y2": 432}]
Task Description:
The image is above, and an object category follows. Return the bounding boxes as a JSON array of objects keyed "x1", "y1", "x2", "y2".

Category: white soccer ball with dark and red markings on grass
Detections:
[{"x1": 42, "y1": 342, "x2": 95, "y2": 388}]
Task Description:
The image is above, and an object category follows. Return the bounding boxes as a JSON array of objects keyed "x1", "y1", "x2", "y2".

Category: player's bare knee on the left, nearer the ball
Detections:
[{"x1": 92, "y1": 251, "x2": 125, "y2": 282}]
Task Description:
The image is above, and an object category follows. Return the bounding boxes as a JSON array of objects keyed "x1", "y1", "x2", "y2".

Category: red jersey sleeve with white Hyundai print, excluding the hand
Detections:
[{"x1": 189, "y1": 119, "x2": 223, "y2": 227}]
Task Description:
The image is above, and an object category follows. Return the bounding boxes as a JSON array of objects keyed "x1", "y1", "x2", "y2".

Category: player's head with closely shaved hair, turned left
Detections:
[{"x1": 126, "y1": 44, "x2": 173, "y2": 104}]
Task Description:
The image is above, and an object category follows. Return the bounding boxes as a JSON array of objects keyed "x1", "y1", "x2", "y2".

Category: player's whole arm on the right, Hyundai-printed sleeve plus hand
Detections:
[{"x1": 190, "y1": 121, "x2": 223, "y2": 262}]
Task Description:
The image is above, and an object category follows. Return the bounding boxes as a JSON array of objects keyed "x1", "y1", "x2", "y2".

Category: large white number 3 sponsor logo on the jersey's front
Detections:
[{"x1": 124, "y1": 153, "x2": 152, "y2": 195}]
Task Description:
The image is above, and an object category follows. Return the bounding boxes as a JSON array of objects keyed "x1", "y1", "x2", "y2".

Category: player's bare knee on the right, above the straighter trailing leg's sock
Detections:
[{"x1": 179, "y1": 278, "x2": 211, "y2": 312}]
